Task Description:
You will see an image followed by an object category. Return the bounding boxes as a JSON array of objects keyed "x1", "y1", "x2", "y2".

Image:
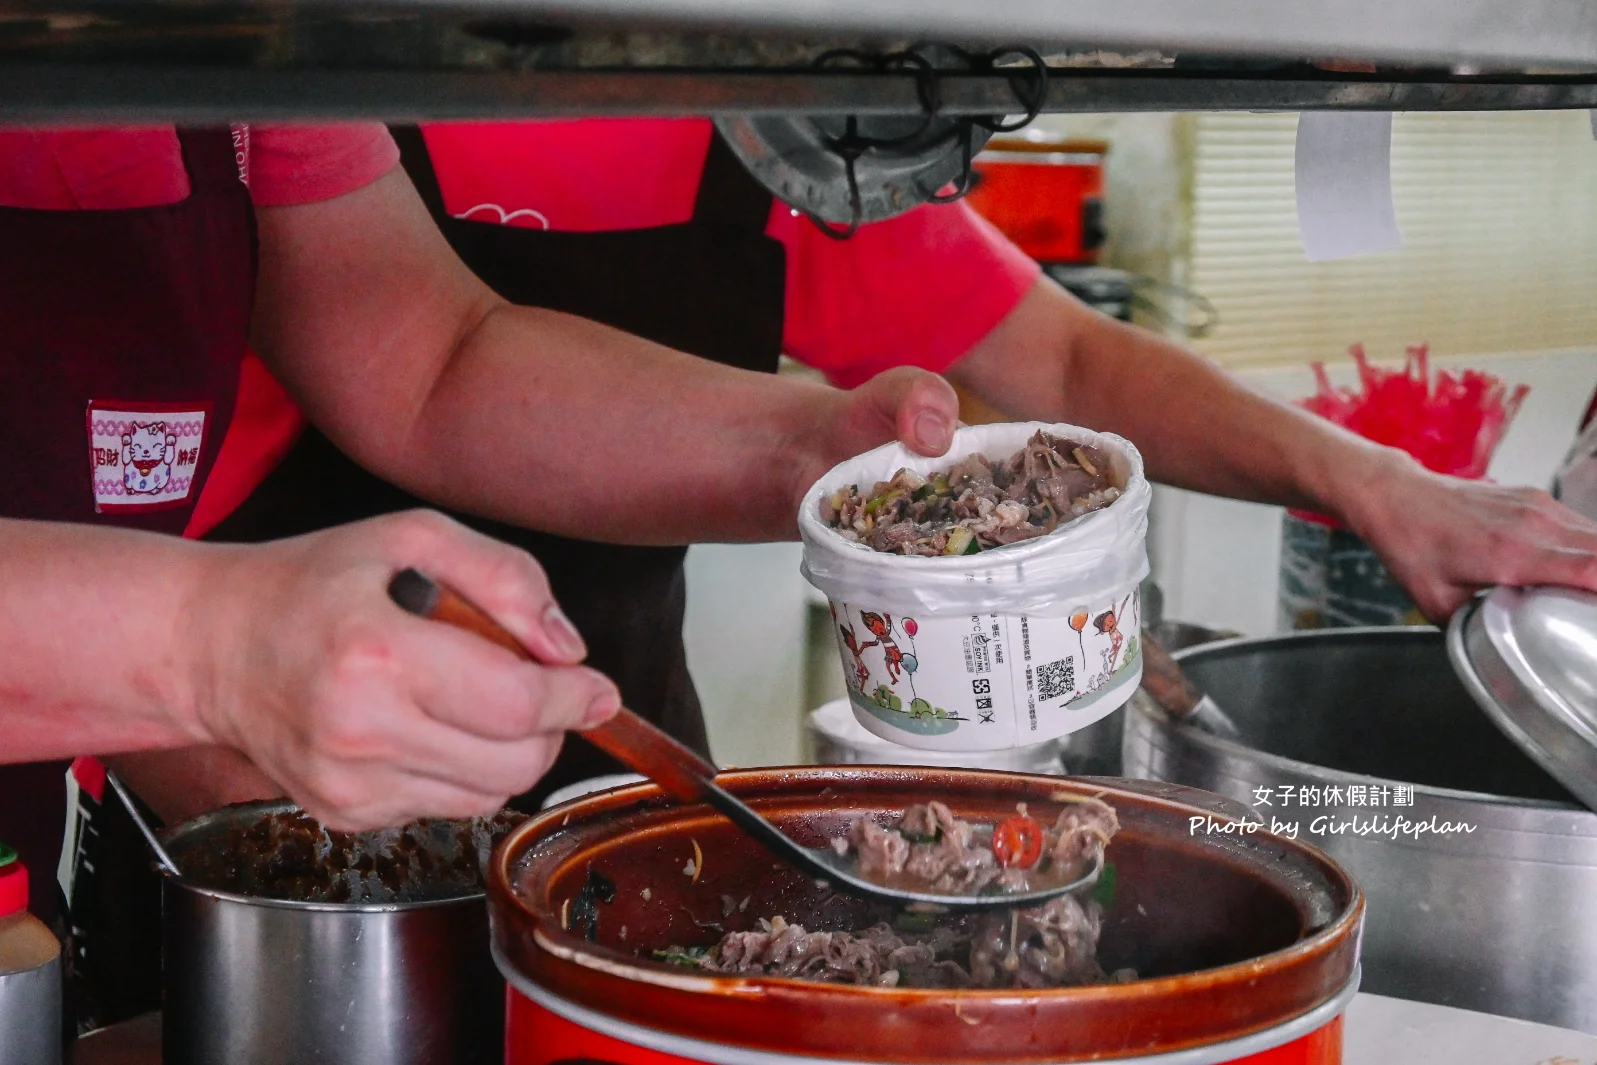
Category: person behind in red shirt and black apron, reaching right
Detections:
[{"x1": 134, "y1": 118, "x2": 1597, "y2": 823}]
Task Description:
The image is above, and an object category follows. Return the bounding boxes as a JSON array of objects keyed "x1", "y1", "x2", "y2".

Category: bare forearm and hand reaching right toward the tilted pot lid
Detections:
[{"x1": 950, "y1": 281, "x2": 1597, "y2": 621}]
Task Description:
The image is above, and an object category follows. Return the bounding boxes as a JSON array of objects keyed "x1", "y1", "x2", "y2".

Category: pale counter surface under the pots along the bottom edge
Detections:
[{"x1": 72, "y1": 995, "x2": 1597, "y2": 1065}]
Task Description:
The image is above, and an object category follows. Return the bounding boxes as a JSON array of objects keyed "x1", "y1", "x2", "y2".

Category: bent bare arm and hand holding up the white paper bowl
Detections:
[{"x1": 254, "y1": 172, "x2": 955, "y2": 544}]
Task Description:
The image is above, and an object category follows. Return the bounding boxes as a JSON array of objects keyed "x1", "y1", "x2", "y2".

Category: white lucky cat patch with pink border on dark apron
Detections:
[{"x1": 88, "y1": 402, "x2": 208, "y2": 513}]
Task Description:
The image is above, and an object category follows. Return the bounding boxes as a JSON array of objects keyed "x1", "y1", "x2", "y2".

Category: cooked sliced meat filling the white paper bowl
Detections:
[{"x1": 821, "y1": 430, "x2": 1119, "y2": 556}]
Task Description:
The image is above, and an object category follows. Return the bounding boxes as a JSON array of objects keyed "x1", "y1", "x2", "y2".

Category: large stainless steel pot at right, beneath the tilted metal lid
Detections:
[{"x1": 1123, "y1": 628, "x2": 1597, "y2": 1033}]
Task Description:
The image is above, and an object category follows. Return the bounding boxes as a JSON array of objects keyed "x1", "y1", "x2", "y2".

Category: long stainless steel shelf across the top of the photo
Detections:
[{"x1": 0, "y1": 0, "x2": 1597, "y2": 123}]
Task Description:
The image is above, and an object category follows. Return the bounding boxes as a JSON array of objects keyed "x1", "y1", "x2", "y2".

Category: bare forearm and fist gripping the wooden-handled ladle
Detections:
[{"x1": 0, "y1": 511, "x2": 635, "y2": 830}]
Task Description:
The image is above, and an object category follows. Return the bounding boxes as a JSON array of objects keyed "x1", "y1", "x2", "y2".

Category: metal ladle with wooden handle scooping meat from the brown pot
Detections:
[{"x1": 388, "y1": 568, "x2": 1104, "y2": 912}]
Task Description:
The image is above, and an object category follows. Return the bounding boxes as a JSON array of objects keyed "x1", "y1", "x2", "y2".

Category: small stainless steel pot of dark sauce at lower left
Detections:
[{"x1": 161, "y1": 803, "x2": 505, "y2": 1065}]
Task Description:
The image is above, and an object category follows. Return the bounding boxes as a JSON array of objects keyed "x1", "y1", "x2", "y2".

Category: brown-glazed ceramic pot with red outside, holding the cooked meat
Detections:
[{"x1": 489, "y1": 766, "x2": 1364, "y2": 1065}]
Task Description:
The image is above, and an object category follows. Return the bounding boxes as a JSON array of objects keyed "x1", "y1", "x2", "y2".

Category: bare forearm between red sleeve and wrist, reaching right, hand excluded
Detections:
[{"x1": 952, "y1": 279, "x2": 1404, "y2": 513}]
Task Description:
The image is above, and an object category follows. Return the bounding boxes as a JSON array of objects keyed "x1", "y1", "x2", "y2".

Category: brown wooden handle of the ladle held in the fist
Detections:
[{"x1": 388, "y1": 570, "x2": 715, "y2": 803}]
